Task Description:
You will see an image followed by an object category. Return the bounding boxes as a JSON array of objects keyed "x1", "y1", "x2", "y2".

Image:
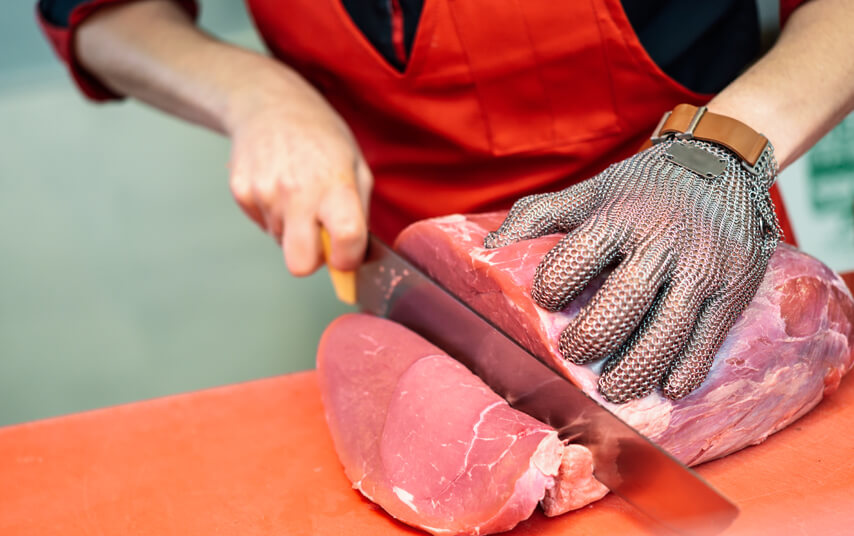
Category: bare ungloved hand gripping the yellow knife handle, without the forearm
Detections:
[{"x1": 229, "y1": 87, "x2": 373, "y2": 276}]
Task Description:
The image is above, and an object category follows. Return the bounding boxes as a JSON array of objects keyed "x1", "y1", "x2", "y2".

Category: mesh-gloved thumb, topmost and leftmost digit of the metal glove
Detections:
[{"x1": 483, "y1": 179, "x2": 599, "y2": 248}]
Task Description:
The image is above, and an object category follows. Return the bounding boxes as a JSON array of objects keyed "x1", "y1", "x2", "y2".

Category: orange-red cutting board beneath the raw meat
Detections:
[{"x1": 0, "y1": 372, "x2": 854, "y2": 536}]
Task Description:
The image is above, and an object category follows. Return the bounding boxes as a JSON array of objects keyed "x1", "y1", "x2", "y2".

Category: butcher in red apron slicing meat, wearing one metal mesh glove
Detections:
[{"x1": 38, "y1": 0, "x2": 854, "y2": 402}]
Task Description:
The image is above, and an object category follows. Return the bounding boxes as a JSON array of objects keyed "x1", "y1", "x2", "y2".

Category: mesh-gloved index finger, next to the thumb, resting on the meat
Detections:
[{"x1": 531, "y1": 216, "x2": 628, "y2": 311}]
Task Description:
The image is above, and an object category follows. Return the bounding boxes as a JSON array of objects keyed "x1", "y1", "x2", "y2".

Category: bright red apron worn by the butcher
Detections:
[{"x1": 242, "y1": 0, "x2": 793, "y2": 245}]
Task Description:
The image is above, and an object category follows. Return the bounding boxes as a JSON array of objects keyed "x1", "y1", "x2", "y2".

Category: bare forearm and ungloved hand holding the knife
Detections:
[{"x1": 75, "y1": 0, "x2": 372, "y2": 275}]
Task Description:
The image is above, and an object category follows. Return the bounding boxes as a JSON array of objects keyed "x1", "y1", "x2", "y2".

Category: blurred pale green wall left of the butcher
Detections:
[{"x1": 0, "y1": 2, "x2": 347, "y2": 425}]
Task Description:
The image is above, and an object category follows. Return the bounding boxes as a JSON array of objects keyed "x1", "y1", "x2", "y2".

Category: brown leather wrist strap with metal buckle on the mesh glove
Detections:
[{"x1": 651, "y1": 104, "x2": 768, "y2": 167}]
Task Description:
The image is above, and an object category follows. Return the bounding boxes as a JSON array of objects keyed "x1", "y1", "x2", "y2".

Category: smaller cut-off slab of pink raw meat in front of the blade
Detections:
[{"x1": 317, "y1": 314, "x2": 607, "y2": 534}]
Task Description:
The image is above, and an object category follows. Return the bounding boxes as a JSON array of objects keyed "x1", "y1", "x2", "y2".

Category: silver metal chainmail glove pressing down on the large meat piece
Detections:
[{"x1": 484, "y1": 139, "x2": 781, "y2": 403}]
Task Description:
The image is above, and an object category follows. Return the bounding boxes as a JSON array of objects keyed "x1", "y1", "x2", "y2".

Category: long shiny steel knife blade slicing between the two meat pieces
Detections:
[{"x1": 355, "y1": 235, "x2": 738, "y2": 536}]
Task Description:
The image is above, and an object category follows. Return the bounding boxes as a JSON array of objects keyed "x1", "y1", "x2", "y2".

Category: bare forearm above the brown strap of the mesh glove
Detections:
[{"x1": 708, "y1": 0, "x2": 854, "y2": 169}]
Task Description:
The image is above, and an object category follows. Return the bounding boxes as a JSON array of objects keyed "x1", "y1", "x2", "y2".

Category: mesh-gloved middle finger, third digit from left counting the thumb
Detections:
[{"x1": 560, "y1": 245, "x2": 674, "y2": 364}]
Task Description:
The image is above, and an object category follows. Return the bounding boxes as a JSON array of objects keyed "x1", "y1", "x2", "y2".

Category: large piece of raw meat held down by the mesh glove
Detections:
[{"x1": 396, "y1": 213, "x2": 854, "y2": 465}]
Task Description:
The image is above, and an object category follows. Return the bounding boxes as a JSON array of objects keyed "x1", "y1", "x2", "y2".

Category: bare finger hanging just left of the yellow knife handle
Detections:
[{"x1": 282, "y1": 194, "x2": 323, "y2": 277}]
